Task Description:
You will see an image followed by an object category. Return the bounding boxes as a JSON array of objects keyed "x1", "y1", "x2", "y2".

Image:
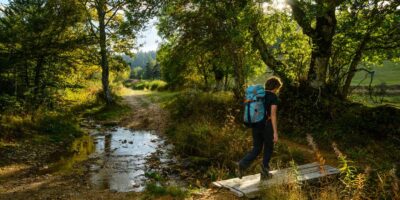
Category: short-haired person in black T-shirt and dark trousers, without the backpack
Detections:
[{"x1": 238, "y1": 77, "x2": 282, "y2": 179}]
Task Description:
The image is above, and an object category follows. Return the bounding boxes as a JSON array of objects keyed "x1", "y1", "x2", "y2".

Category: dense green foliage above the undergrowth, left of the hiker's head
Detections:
[{"x1": 158, "y1": 0, "x2": 264, "y2": 96}]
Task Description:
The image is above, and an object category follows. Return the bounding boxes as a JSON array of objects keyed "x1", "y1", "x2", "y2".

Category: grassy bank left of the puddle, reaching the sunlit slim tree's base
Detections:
[{"x1": 0, "y1": 85, "x2": 130, "y2": 167}]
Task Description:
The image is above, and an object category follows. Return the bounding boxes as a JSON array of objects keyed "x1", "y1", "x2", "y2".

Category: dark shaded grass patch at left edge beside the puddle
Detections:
[{"x1": 0, "y1": 112, "x2": 85, "y2": 167}]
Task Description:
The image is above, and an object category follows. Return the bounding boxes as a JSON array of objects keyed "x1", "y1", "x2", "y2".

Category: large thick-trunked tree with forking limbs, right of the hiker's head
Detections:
[{"x1": 249, "y1": 0, "x2": 400, "y2": 97}]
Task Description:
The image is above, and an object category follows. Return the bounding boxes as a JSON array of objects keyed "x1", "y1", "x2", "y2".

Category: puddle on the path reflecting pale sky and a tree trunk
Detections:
[{"x1": 90, "y1": 128, "x2": 163, "y2": 192}]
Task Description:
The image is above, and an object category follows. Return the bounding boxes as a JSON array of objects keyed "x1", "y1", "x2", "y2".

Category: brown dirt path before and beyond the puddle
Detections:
[{"x1": 0, "y1": 90, "x2": 236, "y2": 200}]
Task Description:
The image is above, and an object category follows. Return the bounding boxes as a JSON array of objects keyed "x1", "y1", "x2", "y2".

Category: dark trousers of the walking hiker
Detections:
[{"x1": 239, "y1": 121, "x2": 274, "y2": 169}]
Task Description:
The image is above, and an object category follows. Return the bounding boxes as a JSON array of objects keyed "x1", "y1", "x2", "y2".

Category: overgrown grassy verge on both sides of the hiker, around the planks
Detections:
[{"x1": 149, "y1": 91, "x2": 400, "y2": 199}]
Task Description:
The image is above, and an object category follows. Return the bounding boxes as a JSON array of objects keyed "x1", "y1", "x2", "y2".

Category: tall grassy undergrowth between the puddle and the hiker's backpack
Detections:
[{"x1": 167, "y1": 91, "x2": 250, "y2": 179}]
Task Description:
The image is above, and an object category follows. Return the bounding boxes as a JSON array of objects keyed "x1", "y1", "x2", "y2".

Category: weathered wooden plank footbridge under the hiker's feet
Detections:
[{"x1": 213, "y1": 163, "x2": 339, "y2": 198}]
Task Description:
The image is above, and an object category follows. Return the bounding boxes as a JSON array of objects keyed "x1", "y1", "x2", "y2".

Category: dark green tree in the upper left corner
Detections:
[{"x1": 0, "y1": 0, "x2": 90, "y2": 107}]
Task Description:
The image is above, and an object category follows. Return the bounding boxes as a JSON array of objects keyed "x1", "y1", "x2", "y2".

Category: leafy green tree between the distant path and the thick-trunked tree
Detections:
[{"x1": 160, "y1": 0, "x2": 260, "y2": 99}]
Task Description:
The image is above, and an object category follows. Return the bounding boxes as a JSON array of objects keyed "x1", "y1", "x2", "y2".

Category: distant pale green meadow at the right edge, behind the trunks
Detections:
[{"x1": 351, "y1": 61, "x2": 400, "y2": 86}]
